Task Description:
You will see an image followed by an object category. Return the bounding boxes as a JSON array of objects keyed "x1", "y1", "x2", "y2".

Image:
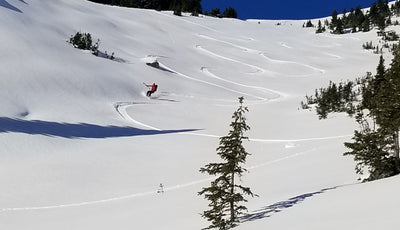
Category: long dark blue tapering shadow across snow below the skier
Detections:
[{"x1": 0, "y1": 117, "x2": 199, "y2": 138}]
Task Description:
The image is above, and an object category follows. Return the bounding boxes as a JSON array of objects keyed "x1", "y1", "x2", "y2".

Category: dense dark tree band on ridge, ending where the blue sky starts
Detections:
[{"x1": 89, "y1": 0, "x2": 202, "y2": 15}]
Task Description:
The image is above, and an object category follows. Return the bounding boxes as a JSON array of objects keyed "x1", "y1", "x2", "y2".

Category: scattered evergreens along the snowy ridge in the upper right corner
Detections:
[{"x1": 304, "y1": 0, "x2": 400, "y2": 34}]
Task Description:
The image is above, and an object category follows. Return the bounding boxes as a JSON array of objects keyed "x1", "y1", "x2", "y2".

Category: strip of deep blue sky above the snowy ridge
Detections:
[{"x1": 201, "y1": 0, "x2": 392, "y2": 19}]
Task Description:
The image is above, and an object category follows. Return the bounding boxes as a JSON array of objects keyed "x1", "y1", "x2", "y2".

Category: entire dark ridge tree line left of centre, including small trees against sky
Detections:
[{"x1": 89, "y1": 0, "x2": 237, "y2": 18}]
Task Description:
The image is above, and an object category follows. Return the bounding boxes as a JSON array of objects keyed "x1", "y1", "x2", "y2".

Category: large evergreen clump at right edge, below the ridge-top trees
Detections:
[{"x1": 301, "y1": 46, "x2": 400, "y2": 181}]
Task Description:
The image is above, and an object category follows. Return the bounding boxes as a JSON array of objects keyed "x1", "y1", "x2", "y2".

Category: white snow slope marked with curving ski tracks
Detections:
[{"x1": 0, "y1": 0, "x2": 400, "y2": 230}]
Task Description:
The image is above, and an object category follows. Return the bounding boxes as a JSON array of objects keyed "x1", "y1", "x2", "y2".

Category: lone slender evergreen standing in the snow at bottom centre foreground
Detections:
[{"x1": 198, "y1": 97, "x2": 254, "y2": 230}]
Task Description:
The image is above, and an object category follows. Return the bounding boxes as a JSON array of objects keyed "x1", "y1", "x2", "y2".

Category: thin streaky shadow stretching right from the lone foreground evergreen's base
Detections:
[{"x1": 240, "y1": 185, "x2": 344, "y2": 222}]
